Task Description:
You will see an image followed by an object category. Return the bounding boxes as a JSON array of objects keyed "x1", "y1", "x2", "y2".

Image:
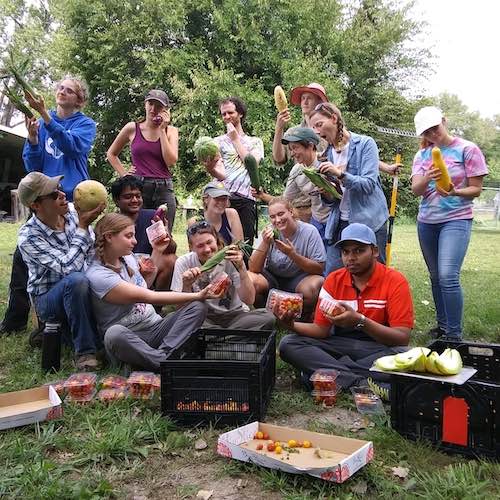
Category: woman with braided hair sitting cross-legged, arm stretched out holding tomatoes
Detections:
[{"x1": 87, "y1": 213, "x2": 223, "y2": 372}]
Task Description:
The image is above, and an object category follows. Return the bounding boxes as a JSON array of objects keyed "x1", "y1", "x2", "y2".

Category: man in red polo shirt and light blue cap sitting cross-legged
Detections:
[{"x1": 274, "y1": 223, "x2": 414, "y2": 388}]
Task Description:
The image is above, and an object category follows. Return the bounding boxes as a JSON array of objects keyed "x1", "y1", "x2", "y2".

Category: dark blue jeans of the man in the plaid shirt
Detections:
[{"x1": 33, "y1": 272, "x2": 102, "y2": 355}]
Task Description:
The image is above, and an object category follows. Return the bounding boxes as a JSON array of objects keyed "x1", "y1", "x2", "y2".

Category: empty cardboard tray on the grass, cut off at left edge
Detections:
[{"x1": 0, "y1": 386, "x2": 62, "y2": 430}]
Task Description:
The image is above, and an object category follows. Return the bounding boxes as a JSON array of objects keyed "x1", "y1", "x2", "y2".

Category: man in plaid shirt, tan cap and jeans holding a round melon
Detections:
[{"x1": 18, "y1": 172, "x2": 105, "y2": 370}]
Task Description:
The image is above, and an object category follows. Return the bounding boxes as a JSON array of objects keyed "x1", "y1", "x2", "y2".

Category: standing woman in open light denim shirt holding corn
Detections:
[{"x1": 310, "y1": 102, "x2": 389, "y2": 276}]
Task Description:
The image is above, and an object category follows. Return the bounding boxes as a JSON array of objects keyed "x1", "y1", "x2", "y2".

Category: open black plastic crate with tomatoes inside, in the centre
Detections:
[{"x1": 161, "y1": 329, "x2": 276, "y2": 426}]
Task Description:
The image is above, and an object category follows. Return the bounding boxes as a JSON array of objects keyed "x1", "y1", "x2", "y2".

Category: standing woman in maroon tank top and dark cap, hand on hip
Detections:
[{"x1": 106, "y1": 90, "x2": 179, "y2": 230}]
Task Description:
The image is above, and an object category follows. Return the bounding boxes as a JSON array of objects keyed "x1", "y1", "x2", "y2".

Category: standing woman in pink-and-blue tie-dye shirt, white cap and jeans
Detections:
[{"x1": 412, "y1": 106, "x2": 488, "y2": 340}]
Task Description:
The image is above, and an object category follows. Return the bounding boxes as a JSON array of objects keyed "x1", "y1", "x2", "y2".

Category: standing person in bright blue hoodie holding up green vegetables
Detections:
[{"x1": 0, "y1": 77, "x2": 96, "y2": 335}]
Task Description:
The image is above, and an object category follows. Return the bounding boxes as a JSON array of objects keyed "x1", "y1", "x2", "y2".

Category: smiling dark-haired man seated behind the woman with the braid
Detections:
[{"x1": 111, "y1": 175, "x2": 177, "y2": 290}]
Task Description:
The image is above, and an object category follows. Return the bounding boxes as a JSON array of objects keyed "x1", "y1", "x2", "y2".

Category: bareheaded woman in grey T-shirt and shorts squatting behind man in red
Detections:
[{"x1": 249, "y1": 198, "x2": 326, "y2": 317}]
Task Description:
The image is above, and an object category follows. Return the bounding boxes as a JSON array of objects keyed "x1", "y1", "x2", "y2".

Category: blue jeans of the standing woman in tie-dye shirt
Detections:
[{"x1": 417, "y1": 219, "x2": 472, "y2": 339}]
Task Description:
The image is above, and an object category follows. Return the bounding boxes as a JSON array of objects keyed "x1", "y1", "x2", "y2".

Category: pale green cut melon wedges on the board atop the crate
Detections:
[{"x1": 374, "y1": 347, "x2": 463, "y2": 375}]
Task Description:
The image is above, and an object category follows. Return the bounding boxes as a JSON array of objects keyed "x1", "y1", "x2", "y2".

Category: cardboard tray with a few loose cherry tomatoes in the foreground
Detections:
[{"x1": 217, "y1": 422, "x2": 373, "y2": 483}]
